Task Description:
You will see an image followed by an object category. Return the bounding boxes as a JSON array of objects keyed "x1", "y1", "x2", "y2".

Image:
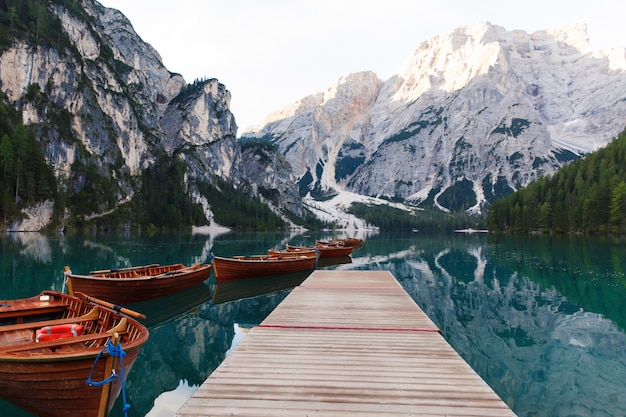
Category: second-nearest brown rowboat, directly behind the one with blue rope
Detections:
[{"x1": 65, "y1": 264, "x2": 211, "y2": 304}]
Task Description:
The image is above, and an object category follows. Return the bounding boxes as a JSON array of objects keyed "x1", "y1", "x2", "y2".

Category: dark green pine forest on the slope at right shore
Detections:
[{"x1": 487, "y1": 128, "x2": 626, "y2": 234}]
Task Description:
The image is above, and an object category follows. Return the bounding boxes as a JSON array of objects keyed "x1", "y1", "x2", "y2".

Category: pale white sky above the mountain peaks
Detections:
[{"x1": 100, "y1": 0, "x2": 626, "y2": 134}]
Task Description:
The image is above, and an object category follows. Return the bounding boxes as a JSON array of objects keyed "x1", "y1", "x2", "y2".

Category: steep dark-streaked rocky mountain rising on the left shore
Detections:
[{"x1": 0, "y1": 0, "x2": 302, "y2": 230}]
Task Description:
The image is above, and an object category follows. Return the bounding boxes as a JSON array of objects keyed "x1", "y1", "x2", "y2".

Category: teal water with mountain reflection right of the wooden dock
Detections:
[{"x1": 394, "y1": 234, "x2": 626, "y2": 416}]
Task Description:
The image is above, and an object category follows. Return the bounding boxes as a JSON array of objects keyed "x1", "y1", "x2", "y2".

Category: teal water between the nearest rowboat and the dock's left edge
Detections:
[{"x1": 112, "y1": 278, "x2": 292, "y2": 416}]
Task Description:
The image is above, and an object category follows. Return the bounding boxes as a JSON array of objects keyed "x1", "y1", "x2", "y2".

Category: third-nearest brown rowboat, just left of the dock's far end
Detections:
[{"x1": 212, "y1": 253, "x2": 317, "y2": 281}]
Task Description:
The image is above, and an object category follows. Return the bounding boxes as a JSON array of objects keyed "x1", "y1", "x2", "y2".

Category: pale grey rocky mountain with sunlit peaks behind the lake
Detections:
[{"x1": 242, "y1": 23, "x2": 626, "y2": 212}]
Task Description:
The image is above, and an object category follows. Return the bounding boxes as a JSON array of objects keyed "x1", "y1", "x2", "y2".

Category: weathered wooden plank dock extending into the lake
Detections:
[{"x1": 176, "y1": 270, "x2": 515, "y2": 417}]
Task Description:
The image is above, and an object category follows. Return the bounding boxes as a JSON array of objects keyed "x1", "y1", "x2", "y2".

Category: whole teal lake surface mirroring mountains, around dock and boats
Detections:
[{"x1": 0, "y1": 233, "x2": 626, "y2": 417}]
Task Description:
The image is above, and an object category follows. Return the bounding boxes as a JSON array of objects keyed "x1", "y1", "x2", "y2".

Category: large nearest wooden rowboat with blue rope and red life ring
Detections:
[{"x1": 0, "y1": 291, "x2": 148, "y2": 417}]
